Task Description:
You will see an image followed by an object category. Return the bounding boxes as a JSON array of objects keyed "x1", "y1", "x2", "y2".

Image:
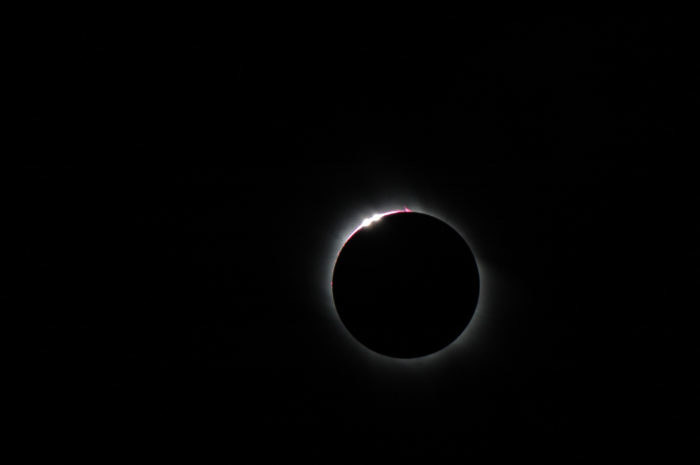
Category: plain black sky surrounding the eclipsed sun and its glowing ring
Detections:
[{"x1": 10, "y1": 18, "x2": 700, "y2": 463}]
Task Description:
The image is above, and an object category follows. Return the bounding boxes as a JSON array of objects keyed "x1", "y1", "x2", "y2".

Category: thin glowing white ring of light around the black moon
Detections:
[{"x1": 326, "y1": 206, "x2": 492, "y2": 367}]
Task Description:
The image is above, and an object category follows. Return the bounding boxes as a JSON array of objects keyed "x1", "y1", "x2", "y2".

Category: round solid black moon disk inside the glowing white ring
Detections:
[{"x1": 332, "y1": 212, "x2": 479, "y2": 358}]
